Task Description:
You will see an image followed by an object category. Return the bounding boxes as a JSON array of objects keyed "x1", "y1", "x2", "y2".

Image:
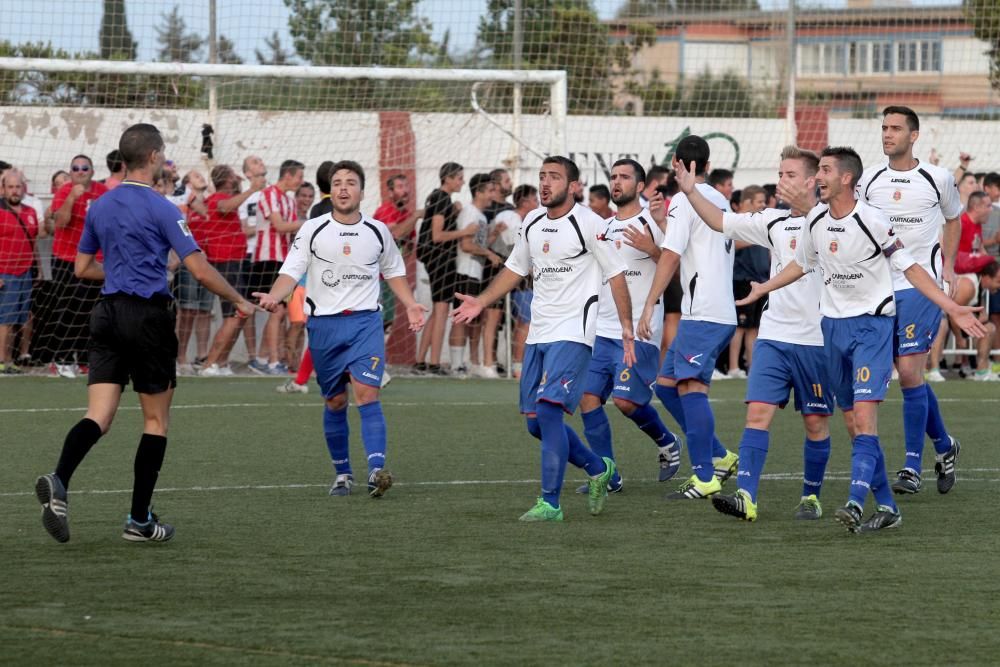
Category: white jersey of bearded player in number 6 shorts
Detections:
[{"x1": 597, "y1": 209, "x2": 663, "y2": 348}]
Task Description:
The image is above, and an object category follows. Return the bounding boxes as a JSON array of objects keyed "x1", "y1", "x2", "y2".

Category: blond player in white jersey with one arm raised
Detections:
[{"x1": 677, "y1": 146, "x2": 833, "y2": 521}]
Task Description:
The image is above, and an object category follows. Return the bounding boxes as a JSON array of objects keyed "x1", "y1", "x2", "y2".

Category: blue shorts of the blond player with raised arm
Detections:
[{"x1": 747, "y1": 338, "x2": 833, "y2": 415}]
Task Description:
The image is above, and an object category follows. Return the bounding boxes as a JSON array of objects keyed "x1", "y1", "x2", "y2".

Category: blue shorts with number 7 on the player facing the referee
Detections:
[{"x1": 306, "y1": 310, "x2": 385, "y2": 398}]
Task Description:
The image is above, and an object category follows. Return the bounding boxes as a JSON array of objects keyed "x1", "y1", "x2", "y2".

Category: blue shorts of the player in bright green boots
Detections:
[{"x1": 521, "y1": 341, "x2": 591, "y2": 414}]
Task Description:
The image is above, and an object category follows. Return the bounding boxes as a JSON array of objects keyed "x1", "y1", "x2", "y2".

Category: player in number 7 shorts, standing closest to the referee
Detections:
[{"x1": 254, "y1": 160, "x2": 424, "y2": 498}]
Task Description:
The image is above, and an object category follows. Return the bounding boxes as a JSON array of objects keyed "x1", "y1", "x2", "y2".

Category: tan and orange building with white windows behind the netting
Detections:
[{"x1": 608, "y1": 0, "x2": 1000, "y2": 117}]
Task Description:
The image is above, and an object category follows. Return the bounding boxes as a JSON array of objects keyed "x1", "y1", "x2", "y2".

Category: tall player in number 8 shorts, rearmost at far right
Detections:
[{"x1": 857, "y1": 106, "x2": 962, "y2": 494}]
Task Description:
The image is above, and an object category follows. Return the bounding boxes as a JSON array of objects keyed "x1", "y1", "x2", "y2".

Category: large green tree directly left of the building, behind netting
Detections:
[{"x1": 477, "y1": 0, "x2": 654, "y2": 113}]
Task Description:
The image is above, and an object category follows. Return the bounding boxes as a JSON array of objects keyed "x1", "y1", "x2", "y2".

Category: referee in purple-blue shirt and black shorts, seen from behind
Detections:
[{"x1": 35, "y1": 123, "x2": 254, "y2": 542}]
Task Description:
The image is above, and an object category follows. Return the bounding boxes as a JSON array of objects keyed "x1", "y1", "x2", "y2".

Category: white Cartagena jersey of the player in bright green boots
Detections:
[{"x1": 505, "y1": 204, "x2": 628, "y2": 347}]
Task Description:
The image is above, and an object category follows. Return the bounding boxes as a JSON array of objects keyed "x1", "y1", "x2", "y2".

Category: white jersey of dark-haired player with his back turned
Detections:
[{"x1": 661, "y1": 183, "x2": 736, "y2": 324}]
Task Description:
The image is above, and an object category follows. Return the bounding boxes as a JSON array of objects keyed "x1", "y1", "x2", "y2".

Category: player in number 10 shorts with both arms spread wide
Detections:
[{"x1": 740, "y1": 148, "x2": 986, "y2": 532}]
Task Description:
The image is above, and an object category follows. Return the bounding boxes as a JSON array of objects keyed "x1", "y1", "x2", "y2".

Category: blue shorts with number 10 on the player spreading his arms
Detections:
[{"x1": 820, "y1": 315, "x2": 895, "y2": 410}]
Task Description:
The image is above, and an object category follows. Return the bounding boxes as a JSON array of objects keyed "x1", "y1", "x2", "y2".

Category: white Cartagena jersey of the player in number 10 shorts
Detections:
[{"x1": 795, "y1": 201, "x2": 916, "y2": 318}]
